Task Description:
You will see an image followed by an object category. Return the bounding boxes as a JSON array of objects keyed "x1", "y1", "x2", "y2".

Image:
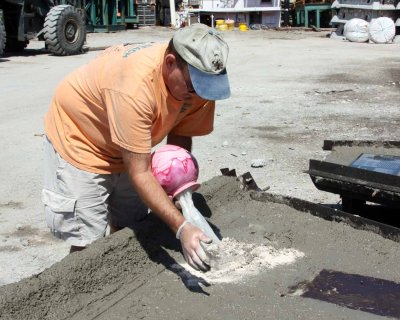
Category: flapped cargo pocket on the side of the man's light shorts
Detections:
[{"x1": 42, "y1": 189, "x2": 79, "y2": 234}]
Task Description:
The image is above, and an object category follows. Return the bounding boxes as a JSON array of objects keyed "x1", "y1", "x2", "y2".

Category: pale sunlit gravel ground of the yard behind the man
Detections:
[{"x1": 0, "y1": 27, "x2": 400, "y2": 285}]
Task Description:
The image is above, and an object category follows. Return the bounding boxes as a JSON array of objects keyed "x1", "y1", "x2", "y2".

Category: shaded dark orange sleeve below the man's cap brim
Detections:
[{"x1": 170, "y1": 101, "x2": 215, "y2": 137}]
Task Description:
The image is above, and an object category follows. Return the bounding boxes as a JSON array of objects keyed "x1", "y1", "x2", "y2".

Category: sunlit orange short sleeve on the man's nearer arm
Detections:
[{"x1": 103, "y1": 89, "x2": 154, "y2": 153}]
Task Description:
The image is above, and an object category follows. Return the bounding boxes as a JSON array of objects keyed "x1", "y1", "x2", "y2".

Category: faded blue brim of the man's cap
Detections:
[{"x1": 188, "y1": 63, "x2": 231, "y2": 100}]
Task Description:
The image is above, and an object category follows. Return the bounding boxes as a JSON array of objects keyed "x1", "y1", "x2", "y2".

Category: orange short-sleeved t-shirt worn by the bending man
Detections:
[{"x1": 45, "y1": 44, "x2": 215, "y2": 173}]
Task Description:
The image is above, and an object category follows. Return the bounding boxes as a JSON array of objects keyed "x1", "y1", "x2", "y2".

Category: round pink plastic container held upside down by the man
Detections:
[{"x1": 151, "y1": 144, "x2": 200, "y2": 197}]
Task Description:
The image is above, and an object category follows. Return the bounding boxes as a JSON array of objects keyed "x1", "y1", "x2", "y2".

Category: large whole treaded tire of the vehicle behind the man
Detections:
[{"x1": 44, "y1": 5, "x2": 86, "y2": 56}]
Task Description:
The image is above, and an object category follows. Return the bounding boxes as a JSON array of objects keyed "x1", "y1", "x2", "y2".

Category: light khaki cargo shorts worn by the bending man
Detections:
[{"x1": 42, "y1": 137, "x2": 148, "y2": 246}]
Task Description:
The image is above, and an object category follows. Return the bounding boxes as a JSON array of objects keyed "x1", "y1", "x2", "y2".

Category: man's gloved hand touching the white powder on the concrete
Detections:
[{"x1": 179, "y1": 222, "x2": 212, "y2": 272}]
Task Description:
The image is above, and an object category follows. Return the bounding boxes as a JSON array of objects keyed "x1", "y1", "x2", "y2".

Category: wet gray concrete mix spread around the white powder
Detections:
[{"x1": 0, "y1": 177, "x2": 400, "y2": 320}]
